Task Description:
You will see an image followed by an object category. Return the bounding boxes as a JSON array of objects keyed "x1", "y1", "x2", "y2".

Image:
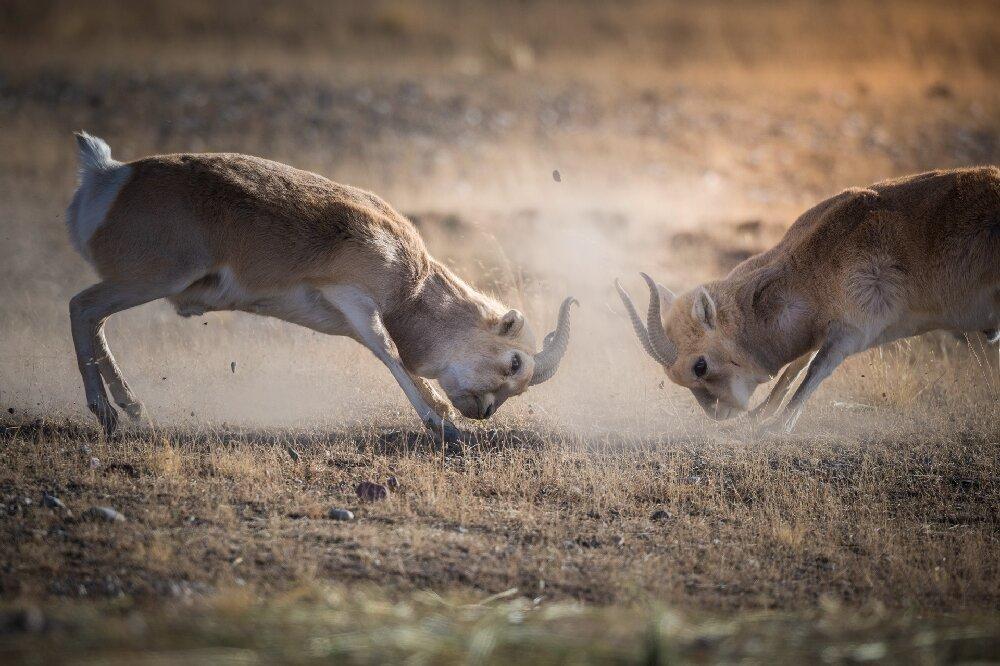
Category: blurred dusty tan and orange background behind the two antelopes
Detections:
[{"x1": 0, "y1": 0, "x2": 1000, "y2": 432}]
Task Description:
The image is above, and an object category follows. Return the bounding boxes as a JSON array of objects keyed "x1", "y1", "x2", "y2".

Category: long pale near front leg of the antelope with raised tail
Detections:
[{"x1": 324, "y1": 287, "x2": 462, "y2": 442}]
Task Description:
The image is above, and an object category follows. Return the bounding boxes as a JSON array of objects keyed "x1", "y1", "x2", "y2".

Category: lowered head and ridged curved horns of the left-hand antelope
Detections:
[{"x1": 438, "y1": 298, "x2": 577, "y2": 419}]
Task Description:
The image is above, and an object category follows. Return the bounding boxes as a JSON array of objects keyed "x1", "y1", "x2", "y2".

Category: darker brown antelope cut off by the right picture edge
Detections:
[{"x1": 615, "y1": 166, "x2": 1000, "y2": 432}]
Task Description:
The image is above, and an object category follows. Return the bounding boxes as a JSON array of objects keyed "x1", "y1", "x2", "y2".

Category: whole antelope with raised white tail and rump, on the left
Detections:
[{"x1": 66, "y1": 132, "x2": 576, "y2": 441}]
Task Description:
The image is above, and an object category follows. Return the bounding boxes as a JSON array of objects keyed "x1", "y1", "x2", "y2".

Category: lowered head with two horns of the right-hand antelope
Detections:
[{"x1": 615, "y1": 273, "x2": 770, "y2": 421}]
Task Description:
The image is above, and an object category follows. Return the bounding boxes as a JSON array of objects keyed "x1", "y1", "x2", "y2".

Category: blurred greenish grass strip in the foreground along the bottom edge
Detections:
[{"x1": 0, "y1": 586, "x2": 1000, "y2": 664}]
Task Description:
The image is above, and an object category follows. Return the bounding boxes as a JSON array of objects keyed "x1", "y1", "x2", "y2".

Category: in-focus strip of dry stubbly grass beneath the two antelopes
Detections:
[{"x1": 0, "y1": 413, "x2": 1000, "y2": 611}]
